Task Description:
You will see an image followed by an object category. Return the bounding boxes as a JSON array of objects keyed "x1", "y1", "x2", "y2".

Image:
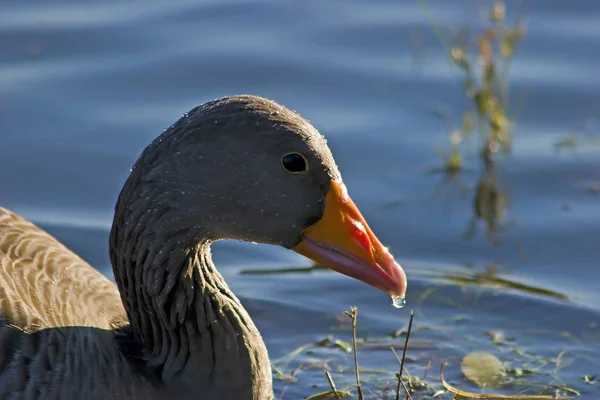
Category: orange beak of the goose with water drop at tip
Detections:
[{"x1": 292, "y1": 182, "x2": 406, "y2": 299}]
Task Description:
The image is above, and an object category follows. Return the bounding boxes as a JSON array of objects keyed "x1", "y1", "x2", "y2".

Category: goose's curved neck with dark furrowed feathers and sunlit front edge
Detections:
[{"x1": 110, "y1": 202, "x2": 272, "y2": 399}]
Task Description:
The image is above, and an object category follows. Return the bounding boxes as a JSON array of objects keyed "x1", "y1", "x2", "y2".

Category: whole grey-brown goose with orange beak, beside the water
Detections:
[{"x1": 0, "y1": 95, "x2": 406, "y2": 400}]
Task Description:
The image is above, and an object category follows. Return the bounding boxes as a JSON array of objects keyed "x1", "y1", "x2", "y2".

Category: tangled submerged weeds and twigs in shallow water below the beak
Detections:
[{"x1": 266, "y1": 302, "x2": 584, "y2": 400}]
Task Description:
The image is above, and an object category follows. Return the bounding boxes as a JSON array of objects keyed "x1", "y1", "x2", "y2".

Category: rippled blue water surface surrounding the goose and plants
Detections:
[{"x1": 0, "y1": 0, "x2": 600, "y2": 399}]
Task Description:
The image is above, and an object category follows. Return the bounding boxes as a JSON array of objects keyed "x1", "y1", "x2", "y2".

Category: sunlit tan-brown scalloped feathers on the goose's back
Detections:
[{"x1": 0, "y1": 207, "x2": 126, "y2": 333}]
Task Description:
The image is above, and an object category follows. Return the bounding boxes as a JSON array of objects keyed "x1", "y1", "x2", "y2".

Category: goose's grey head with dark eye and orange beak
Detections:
[{"x1": 121, "y1": 95, "x2": 406, "y2": 298}]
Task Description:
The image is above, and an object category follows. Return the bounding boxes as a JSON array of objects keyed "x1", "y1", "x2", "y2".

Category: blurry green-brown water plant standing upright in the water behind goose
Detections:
[{"x1": 419, "y1": 0, "x2": 527, "y2": 172}]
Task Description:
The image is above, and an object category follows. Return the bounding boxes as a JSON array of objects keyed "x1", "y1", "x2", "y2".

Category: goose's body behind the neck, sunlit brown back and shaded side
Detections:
[{"x1": 0, "y1": 207, "x2": 152, "y2": 399}]
